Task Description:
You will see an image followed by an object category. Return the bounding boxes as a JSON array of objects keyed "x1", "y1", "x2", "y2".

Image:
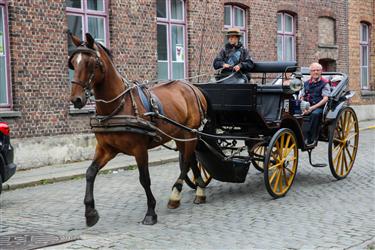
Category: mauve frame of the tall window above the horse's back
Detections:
[{"x1": 156, "y1": 0, "x2": 188, "y2": 80}]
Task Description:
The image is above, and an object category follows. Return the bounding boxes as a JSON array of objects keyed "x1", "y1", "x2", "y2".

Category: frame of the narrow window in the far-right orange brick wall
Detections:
[{"x1": 359, "y1": 22, "x2": 371, "y2": 89}]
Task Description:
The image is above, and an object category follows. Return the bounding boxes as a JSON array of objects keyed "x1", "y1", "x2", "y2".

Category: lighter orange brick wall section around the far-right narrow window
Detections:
[{"x1": 348, "y1": 0, "x2": 375, "y2": 104}]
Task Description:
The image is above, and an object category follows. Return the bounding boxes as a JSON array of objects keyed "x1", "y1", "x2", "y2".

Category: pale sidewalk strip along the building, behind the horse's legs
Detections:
[{"x1": 3, "y1": 120, "x2": 375, "y2": 191}]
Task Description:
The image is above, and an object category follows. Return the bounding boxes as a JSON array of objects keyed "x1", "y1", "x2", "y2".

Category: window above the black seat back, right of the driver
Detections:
[{"x1": 277, "y1": 12, "x2": 296, "y2": 61}]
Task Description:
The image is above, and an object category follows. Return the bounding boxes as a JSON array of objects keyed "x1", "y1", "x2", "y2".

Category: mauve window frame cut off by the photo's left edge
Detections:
[{"x1": 0, "y1": 0, "x2": 13, "y2": 111}]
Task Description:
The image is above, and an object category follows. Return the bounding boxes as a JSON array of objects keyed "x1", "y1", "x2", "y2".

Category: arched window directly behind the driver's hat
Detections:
[{"x1": 224, "y1": 5, "x2": 247, "y2": 47}]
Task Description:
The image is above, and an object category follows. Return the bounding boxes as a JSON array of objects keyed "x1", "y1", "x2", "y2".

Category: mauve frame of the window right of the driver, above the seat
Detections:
[{"x1": 276, "y1": 11, "x2": 297, "y2": 61}]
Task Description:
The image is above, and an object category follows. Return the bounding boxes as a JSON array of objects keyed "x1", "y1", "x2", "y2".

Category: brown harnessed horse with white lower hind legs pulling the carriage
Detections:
[{"x1": 69, "y1": 34, "x2": 207, "y2": 226}]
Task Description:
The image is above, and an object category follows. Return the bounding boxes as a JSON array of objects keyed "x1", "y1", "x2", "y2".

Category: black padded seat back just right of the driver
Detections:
[{"x1": 250, "y1": 61, "x2": 297, "y2": 73}]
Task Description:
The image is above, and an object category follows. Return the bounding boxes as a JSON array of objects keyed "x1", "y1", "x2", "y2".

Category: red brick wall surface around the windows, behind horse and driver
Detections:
[{"x1": 0, "y1": 0, "x2": 375, "y2": 137}]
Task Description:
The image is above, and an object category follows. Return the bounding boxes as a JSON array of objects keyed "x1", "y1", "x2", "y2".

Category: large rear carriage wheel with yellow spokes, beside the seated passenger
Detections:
[{"x1": 328, "y1": 107, "x2": 359, "y2": 180}]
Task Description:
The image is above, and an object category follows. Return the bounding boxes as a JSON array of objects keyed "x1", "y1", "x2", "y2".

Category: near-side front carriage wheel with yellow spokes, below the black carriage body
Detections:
[{"x1": 264, "y1": 128, "x2": 298, "y2": 198}]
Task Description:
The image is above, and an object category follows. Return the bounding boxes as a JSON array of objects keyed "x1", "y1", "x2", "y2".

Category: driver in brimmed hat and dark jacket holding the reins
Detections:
[{"x1": 213, "y1": 28, "x2": 254, "y2": 83}]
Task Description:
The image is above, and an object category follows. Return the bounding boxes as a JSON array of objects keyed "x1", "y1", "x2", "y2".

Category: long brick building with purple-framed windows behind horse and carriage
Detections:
[{"x1": 0, "y1": 0, "x2": 375, "y2": 141}]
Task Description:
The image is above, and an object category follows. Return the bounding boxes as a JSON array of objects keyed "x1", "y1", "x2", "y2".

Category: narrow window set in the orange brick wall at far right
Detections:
[{"x1": 360, "y1": 23, "x2": 370, "y2": 89}]
